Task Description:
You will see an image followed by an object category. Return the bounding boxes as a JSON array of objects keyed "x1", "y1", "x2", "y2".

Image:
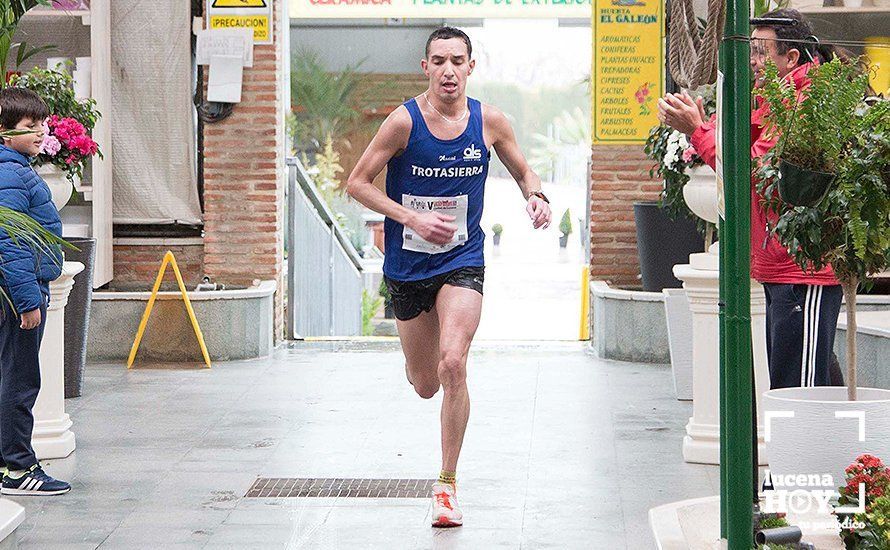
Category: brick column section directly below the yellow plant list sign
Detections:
[{"x1": 590, "y1": 145, "x2": 662, "y2": 286}]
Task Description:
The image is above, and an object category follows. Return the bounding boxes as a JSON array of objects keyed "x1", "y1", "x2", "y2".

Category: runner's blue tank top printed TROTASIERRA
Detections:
[{"x1": 383, "y1": 98, "x2": 491, "y2": 281}]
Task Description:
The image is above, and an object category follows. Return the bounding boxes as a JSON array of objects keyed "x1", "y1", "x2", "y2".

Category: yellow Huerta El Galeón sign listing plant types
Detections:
[{"x1": 591, "y1": 0, "x2": 664, "y2": 144}]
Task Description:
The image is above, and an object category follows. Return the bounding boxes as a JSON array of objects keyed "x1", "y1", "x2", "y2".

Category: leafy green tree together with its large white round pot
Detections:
[{"x1": 758, "y1": 60, "x2": 890, "y2": 488}]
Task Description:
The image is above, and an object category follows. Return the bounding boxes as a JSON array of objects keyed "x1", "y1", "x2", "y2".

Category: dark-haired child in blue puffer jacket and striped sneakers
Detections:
[{"x1": 0, "y1": 88, "x2": 71, "y2": 495}]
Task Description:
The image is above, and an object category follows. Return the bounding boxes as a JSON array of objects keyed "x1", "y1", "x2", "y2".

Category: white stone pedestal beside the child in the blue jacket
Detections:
[{"x1": 31, "y1": 262, "x2": 84, "y2": 459}]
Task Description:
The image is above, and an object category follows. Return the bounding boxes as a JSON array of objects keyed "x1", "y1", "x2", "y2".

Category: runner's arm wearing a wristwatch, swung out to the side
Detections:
[{"x1": 483, "y1": 105, "x2": 551, "y2": 229}]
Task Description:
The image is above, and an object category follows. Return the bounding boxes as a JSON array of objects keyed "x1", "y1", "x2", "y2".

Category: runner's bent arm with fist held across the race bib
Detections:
[{"x1": 346, "y1": 107, "x2": 457, "y2": 244}]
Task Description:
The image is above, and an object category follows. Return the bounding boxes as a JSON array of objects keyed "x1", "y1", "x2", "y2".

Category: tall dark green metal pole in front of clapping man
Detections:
[{"x1": 720, "y1": 0, "x2": 754, "y2": 550}]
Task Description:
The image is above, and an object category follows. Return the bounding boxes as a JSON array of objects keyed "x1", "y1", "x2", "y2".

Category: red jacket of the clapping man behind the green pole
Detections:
[{"x1": 689, "y1": 63, "x2": 838, "y2": 285}]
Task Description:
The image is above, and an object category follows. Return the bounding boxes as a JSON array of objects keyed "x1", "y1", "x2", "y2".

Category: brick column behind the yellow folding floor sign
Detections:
[{"x1": 204, "y1": 0, "x2": 290, "y2": 341}]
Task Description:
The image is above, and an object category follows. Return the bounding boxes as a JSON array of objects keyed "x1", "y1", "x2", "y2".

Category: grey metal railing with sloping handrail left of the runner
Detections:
[{"x1": 286, "y1": 158, "x2": 363, "y2": 340}]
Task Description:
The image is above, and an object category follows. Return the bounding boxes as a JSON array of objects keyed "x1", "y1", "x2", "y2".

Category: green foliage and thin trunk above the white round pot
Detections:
[{"x1": 758, "y1": 60, "x2": 890, "y2": 400}]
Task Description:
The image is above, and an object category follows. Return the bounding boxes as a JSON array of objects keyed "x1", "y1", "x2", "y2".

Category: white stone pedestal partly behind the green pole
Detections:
[{"x1": 674, "y1": 245, "x2": 769, "y2": 465}]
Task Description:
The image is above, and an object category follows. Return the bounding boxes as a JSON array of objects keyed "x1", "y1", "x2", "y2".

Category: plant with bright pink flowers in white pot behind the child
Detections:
[{"x1": 10, "y1": 67, "x2": 102, "y2": 209}]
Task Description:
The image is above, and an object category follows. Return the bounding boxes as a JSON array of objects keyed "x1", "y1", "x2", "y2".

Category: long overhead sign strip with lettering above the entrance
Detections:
[{"x1": 289, "y1": 0, "x2": 591, "y2": 19}]
